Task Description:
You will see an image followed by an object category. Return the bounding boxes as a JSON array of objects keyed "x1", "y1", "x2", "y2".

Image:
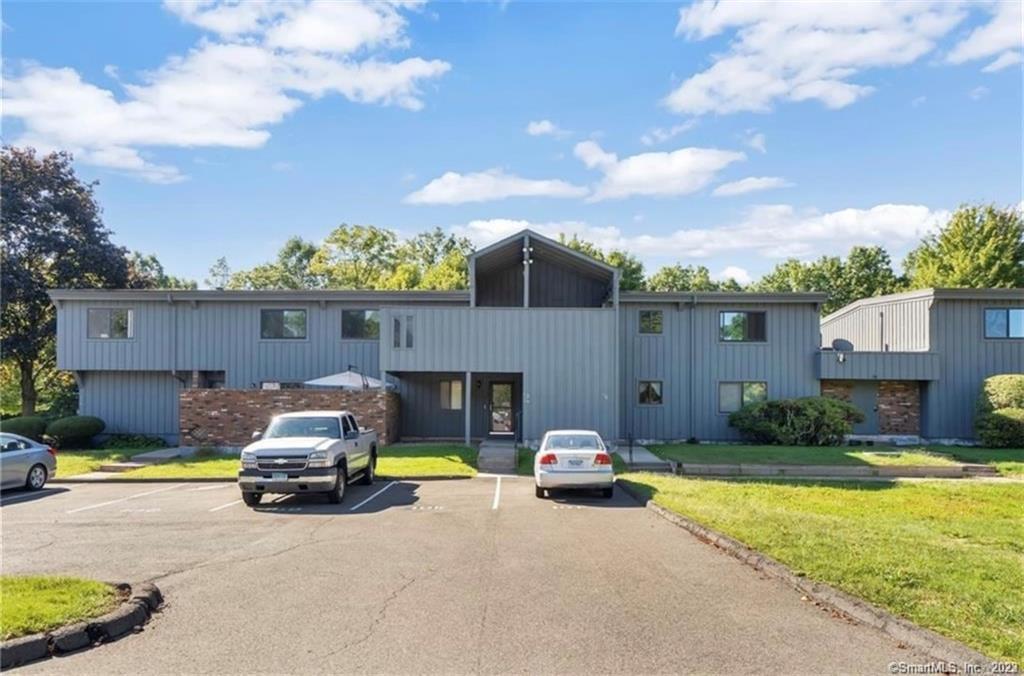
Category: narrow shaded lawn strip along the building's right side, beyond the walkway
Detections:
[{"x1": 647, "y1": 443, "x2": 1024, "y2": 475}]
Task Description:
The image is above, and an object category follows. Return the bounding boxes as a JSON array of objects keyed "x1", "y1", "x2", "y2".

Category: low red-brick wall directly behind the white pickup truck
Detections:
[{"x1": 178, "y1": 389, "x2": 398, "y2": 447}]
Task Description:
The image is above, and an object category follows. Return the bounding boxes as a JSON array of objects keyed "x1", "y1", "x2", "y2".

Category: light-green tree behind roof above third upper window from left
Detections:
[{"x1": 309, "y1": 223, "x2": 398, "y2": 289}]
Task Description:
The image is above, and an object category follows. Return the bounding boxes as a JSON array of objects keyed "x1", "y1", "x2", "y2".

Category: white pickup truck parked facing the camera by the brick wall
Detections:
[{"x1": 239, "y1": 411, "x2": 377, "y2": 507}]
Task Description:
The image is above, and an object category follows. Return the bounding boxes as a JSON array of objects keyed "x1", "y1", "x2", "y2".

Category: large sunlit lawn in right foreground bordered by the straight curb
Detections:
[{"x1": 622, "y1": 473, "x2": 1024, "y2": 663}]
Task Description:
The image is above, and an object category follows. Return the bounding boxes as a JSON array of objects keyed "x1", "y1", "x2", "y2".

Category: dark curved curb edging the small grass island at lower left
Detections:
[{"x1": 0, "y1": 583, "x2": 164, "y2": 669}]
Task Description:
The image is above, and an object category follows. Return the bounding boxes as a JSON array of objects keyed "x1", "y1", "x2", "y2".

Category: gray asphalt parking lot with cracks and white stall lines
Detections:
[{"x1": 0, "y1": 477, "x2": 928, "y2": 674}]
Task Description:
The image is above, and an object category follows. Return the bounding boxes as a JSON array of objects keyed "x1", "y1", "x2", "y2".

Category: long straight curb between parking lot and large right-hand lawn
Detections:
[{"x1": 615, "y1": 479, "x2": 993, "y2": 674}]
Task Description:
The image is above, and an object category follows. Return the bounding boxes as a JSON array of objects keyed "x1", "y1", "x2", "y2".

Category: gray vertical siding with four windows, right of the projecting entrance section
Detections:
[{"x1": 618, "y1": 303, "x2": 820, "y2": 440}]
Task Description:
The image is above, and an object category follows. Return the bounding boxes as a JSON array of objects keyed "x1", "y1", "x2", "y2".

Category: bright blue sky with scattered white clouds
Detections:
[{"x1": 2, "y1": 0, "x2": 1024, "y2": 283}]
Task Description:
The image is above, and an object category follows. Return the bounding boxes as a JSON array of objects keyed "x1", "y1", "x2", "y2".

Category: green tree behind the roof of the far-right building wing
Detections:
[{"x1": 903, "y1": 204, "x2": 1024, "y2": 289}]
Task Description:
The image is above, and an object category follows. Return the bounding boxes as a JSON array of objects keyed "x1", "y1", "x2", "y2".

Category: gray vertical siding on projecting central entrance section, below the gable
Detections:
[{"x1": 381, "y1": 306, "x2": 618, "y2": 439}]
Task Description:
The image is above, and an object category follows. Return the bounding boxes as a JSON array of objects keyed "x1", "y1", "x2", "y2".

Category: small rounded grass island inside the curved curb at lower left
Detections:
[{"x1": 0, "y1": 576, "x2": 117, "y2": 639}]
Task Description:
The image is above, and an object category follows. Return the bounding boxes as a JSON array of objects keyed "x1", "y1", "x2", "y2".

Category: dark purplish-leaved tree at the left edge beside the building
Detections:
[{"x1": 0, "y1": 146, "x2": 128, "y2": 415}]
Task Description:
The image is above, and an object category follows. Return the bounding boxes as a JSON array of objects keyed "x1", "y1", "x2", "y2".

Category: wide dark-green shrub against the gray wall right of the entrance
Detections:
[{"x1": 729, "y1": 396, "x2": 864, "y2": 446}]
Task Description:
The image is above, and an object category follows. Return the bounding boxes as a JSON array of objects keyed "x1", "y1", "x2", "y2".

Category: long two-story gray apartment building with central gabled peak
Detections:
[{"x1": 51, "y1": 230, "x2": 1024, "y2": 442}]
